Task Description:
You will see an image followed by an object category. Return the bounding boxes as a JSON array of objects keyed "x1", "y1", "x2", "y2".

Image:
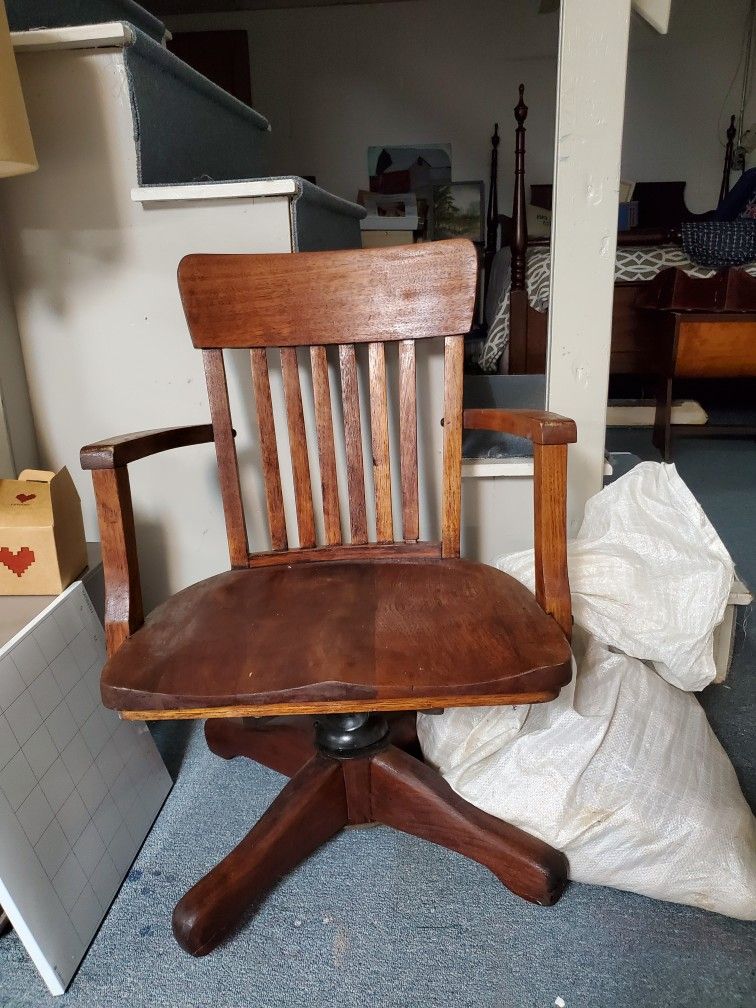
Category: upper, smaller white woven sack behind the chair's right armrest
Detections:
[{"x1": 504, "y1": 462, "x2": 734, "y2": 689}]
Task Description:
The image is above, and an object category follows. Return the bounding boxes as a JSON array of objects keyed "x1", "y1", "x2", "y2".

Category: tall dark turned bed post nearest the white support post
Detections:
[{"x1": 510, "y1": 84, "x2": 527, "y2": 374}]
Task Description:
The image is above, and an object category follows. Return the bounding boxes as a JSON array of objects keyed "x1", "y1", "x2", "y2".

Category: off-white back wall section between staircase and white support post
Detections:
[{"x1": 167, "y1": 0, "x2": 558, "y2": 207}]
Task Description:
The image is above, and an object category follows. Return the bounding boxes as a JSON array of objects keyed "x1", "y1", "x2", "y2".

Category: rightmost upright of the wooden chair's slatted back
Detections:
[{"x1": 442, "y1": 336, "x2": 465, "y2": 556}]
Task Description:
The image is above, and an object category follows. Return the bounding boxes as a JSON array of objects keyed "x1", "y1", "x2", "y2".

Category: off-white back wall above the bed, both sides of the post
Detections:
[{"x1": 166, "y1": 0, "x2": 748, "y2": 210}]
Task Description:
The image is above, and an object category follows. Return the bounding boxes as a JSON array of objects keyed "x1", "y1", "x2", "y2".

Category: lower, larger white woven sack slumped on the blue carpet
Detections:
[{"x1": 417, "y1": 630, "x2": 756, "y2": 920}]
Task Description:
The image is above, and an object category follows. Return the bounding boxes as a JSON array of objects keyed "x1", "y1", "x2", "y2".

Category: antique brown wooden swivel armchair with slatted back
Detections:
[{"x1": 82, "y1": 241, "x2": 576, "y2": 956}]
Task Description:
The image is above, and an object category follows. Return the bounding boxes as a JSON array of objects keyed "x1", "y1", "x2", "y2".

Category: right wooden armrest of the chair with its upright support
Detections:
[{"x1": 463, "y1": 409, "x2": 578, "y2": 640}]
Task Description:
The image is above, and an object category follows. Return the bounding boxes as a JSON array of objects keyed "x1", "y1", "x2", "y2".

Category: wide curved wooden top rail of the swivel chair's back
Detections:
[{"x1": 178, "y1": 239, "x2": 478, "y2": 350}]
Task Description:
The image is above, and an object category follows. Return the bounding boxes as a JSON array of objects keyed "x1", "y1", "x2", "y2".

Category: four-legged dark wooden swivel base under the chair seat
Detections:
[{"x1": 173, "y1": 714, "x2": 568, "y2": 956}]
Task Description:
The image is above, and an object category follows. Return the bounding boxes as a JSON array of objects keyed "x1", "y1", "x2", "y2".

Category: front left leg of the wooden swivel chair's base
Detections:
[{"x1": 173, "y1": 755, "x2": 347, "y2": 956}]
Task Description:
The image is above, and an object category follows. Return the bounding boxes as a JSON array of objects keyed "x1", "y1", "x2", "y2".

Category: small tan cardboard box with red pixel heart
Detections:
[{"x1": 0, "y1": 469, "x2": 87, "y2": 595}]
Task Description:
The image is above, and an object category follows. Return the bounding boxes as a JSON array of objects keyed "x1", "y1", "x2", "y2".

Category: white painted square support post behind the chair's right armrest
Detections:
[{"x1": 546, "y1": 0, "x2": 630, "y2": 534}]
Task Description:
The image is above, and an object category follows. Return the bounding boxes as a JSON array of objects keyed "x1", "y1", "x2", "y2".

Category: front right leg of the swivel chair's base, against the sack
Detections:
[{"x1": 370, "y1": 746, "x2": 568, "y2": 906}]
